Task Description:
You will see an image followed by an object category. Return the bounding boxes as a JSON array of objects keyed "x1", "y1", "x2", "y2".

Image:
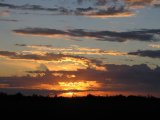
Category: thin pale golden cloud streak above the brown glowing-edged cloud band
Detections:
[{"x1": 15, "y1": 44, "x2": 127, "y2": 56}]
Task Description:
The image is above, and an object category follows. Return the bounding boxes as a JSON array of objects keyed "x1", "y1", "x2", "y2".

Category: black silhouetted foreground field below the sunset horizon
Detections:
[{"x1": 0, "y1": 93, "x2": 160, "y2": 119}]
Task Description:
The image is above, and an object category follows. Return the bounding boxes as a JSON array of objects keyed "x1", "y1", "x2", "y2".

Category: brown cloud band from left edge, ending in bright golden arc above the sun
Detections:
[{"x1": 0, "y1": 51, "x2": 106, "y2": 71}]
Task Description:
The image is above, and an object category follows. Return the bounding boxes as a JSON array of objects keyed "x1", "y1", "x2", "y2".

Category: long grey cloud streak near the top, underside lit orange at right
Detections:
[{"x1": 0, "y1": 0, "x2": 133, "y2": 17}]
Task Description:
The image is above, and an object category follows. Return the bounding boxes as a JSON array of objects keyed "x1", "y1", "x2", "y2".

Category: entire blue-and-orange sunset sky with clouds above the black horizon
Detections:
[{"x1": 0, "y1": 0, "x2": 160, "y2": 97}]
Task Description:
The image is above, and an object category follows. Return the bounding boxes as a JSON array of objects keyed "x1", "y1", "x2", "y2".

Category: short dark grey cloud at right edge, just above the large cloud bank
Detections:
[{"x1": 128, "y1": 50, "x2": 160, "y2": 58}]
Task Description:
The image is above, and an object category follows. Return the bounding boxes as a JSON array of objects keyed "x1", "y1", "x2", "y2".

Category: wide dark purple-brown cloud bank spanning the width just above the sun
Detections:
[{"x1": 0, "y1": 64, "x2": 160, "y2": 93}]
